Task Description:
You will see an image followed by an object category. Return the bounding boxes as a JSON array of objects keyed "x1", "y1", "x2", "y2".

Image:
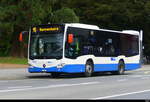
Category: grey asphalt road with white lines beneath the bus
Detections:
[{"x1": 0, "y1": 65, "x2": 150, "y2": 100}]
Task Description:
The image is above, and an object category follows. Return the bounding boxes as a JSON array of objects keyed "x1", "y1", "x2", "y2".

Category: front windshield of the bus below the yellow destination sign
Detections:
[{"x1": 29, "y1": 24, "x2": 64, "y2": 59}]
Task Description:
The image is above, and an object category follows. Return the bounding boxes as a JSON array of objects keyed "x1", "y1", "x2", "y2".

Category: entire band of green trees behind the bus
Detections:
[{"x1": 0, "y1": 0, "x2": 150, "y2": 56}]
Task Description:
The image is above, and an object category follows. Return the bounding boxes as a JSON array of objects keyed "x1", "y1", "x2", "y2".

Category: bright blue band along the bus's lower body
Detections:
[{"x1": 28, "y1": 63, "x2": 141, "y2": 73}]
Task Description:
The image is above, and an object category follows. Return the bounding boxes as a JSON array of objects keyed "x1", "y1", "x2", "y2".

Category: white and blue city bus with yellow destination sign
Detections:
[{"x1": 28, "y1": 23, "x2": 142, "y2": 77}]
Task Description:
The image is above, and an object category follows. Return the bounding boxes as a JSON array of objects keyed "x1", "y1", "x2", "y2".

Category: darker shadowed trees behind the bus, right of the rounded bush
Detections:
[{"x1": 61, "y1": 0, "x2": 150, "y2": 56}]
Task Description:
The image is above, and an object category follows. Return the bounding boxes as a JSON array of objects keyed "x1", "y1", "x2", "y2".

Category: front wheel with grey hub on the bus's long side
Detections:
[{"x1": 84, "y1": 61, "x2": 93, "y2": 77}]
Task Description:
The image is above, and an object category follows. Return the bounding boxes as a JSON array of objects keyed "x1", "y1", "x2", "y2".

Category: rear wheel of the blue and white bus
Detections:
[{"x1": 112, "y1": 60, "x2": 125, "y2": 75}]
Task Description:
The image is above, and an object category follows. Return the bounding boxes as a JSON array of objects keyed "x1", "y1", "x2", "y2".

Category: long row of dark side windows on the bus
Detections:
[{"x1": 65, "y1": 27, "x2": 139, "y2": 58}]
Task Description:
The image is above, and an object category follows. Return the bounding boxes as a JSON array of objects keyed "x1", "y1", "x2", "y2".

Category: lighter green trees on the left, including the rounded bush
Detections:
[{"x1": 0, "y1": 0, "x2": 78, "y2": 56}]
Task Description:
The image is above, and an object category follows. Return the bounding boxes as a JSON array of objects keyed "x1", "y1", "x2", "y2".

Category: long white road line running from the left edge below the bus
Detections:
[{"x1": 0, "y1": 82, "x2": 100, "y2": 93}]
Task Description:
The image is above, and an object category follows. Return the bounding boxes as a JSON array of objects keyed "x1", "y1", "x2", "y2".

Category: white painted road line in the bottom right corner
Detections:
[{"x1": 93, "y1": 89, "x2": 150, "y2": 100}]
